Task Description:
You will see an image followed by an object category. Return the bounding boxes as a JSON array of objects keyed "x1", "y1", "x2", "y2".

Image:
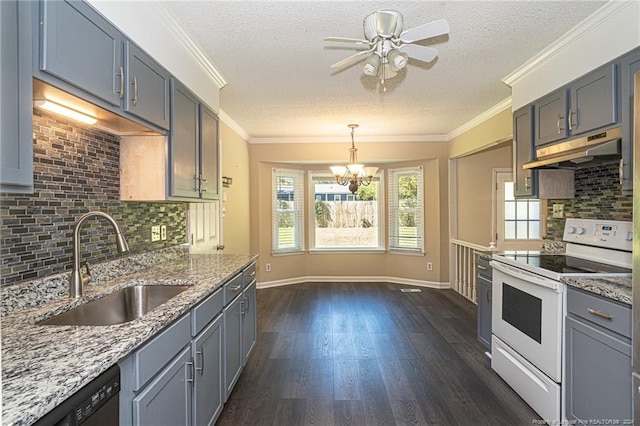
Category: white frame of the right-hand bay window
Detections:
[{"x1": 387, "y1": 166, "x2": 425, "y2": 255}]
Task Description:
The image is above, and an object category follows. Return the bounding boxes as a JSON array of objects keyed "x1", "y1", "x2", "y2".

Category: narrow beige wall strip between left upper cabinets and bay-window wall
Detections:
[{"x1": 220, "y1": 122, "x2": 251, "y2": 254}]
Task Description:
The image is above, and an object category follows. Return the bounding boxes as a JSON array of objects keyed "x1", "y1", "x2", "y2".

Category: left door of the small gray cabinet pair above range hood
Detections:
[{"x1": 533, "y1": 89, "x2": 569, "y2": 146}]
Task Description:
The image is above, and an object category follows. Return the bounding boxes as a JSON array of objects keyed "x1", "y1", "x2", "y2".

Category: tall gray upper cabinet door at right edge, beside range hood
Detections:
[{"x1": 621, "y1": 48, "x2": 640, "y2": 195}]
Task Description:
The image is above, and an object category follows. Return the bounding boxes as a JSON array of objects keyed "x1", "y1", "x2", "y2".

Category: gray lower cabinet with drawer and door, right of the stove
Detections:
[{"x1": 565, "y1": 288, "x2": 632, "y2": 424}]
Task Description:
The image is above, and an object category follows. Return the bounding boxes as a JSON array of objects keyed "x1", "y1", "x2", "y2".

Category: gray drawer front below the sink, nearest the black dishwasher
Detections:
[{"x1": 133, "y1": 314, "x2": 191, "y2": 391}]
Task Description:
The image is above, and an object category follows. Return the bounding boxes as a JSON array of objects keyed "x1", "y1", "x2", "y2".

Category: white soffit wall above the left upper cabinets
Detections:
[{"x1": 88, "y1": 0, "x2": 226, "y2": 112}]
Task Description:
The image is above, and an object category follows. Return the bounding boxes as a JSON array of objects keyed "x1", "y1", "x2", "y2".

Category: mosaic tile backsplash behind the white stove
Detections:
[{"x1": 547, "y1": 162, "x2": 633, "y2": 240}]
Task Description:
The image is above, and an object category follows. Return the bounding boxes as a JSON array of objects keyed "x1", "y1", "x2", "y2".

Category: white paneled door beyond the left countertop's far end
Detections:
[{"x1": 187, "y1": 201, "x2": 222, "y2": 253}]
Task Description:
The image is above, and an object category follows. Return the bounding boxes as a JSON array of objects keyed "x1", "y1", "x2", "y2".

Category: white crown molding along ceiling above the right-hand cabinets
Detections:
[{"x1": 502, "y1": 0, "x2": 637, "y2": 87}]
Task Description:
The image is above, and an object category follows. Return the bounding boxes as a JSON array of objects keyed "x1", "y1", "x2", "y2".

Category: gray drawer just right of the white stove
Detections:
[{"x1": 567, "y1": 287, "x2": 631, "y2": 339}]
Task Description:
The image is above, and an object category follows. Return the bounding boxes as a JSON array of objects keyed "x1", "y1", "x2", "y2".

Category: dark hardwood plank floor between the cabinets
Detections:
[{"x1": 217, "y1": 283, "x2": 539, "y2": 426}]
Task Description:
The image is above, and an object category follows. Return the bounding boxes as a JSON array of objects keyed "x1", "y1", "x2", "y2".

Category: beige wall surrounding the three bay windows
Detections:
[{"x1": 249, "y1": 142, "x2": 449, "y2": 283}]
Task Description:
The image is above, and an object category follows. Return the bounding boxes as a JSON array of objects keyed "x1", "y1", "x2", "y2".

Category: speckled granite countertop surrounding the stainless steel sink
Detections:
[{"x1": 2, "y1": 254, "x2": 257, "y2": 425}]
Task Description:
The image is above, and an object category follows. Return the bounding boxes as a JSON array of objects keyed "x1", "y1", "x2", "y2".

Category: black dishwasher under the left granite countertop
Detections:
[{"x1": 35, "y1": 364, "x2": 120, "y2": 426}]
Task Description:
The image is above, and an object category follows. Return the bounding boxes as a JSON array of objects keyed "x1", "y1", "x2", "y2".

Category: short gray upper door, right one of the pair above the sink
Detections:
[{"x1": 124, "y1": 40, "x2": 170, "y2": 129}]
